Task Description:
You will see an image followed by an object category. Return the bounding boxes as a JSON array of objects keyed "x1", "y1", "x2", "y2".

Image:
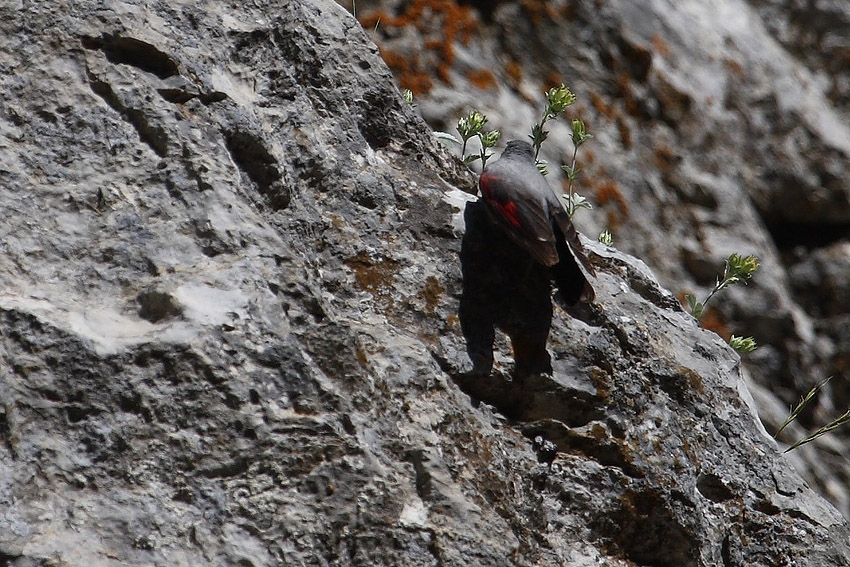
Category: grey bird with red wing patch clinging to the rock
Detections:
[{"x1": 479, "y1": 140, "x2": 596, "y2": 305}]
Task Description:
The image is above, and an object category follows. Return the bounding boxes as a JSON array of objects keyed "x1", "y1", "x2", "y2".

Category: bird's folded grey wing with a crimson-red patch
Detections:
[{"x1": 479, "y1": 170, "x2": 558, "y2": 266}]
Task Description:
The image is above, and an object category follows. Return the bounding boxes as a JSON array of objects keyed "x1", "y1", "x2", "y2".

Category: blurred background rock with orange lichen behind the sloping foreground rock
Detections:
[{"x1": 352, "y1": 0, "x2": 850, "y2": 517}]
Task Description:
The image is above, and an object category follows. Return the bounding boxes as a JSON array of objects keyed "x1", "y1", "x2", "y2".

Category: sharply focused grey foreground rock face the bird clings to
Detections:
[{"x1": 0, "y1": 0, "x2": 850, "y2": 567}]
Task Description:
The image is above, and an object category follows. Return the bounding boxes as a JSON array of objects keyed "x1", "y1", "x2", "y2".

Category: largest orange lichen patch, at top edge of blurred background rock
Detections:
[{"x1": 358, "y1": 0, "x2": 476, "y2": 94}]
